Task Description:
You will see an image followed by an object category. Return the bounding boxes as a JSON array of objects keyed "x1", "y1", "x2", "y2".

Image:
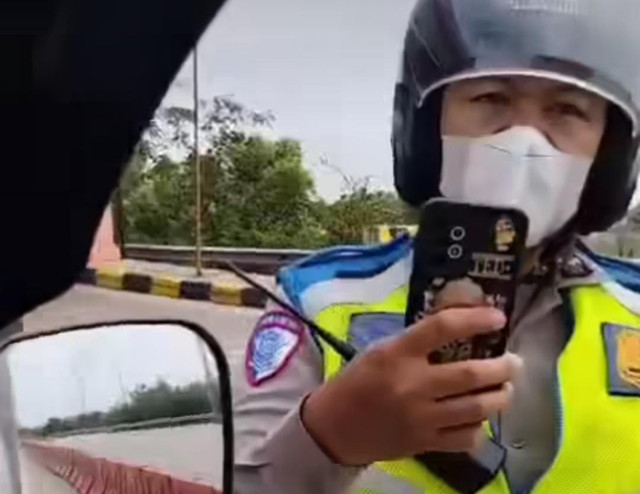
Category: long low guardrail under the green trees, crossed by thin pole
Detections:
[{"x1": 124, "y1": 244, "x2": 313, "y2": 275}]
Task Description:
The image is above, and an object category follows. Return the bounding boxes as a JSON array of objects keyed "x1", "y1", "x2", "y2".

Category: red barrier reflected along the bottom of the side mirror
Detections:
[{"x1": 22, "y1": 441, "x2": 222, "y2": 494}]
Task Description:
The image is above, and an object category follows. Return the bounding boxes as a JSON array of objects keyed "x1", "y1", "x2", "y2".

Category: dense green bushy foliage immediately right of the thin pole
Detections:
[{"x1": 205, "y1": 136, "x2": 326, "y2": 248}]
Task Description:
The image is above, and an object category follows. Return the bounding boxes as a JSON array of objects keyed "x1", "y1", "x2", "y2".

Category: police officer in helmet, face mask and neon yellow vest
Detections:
[{"x1": 236, "y1": 0, "x2": 640, "y2": 494}]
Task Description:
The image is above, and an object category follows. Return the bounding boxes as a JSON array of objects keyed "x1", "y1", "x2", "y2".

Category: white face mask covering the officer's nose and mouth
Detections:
[{"x1": 440, "y1": 127, "x2": 593, "y2": 247}]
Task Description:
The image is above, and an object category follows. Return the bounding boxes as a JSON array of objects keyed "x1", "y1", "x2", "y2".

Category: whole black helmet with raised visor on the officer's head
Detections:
[{"x1": 392, "y1": 0, "x2": 640, "y2": 234}]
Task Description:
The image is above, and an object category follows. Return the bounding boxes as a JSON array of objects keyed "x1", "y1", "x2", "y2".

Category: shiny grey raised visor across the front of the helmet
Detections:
[{"x1": 407, "y1": 0, "x2": 640, "y2": 135}]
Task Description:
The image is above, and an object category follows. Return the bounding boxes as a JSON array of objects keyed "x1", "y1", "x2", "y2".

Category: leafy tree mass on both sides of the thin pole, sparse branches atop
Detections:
[{"x1": 121, "y1": 98, "x2": 326, "y2": 248}]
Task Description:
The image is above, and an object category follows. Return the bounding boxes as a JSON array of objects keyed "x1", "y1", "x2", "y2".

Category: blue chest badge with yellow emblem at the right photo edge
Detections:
[{"x1": 603, "y1": 324, "x2": 640, "y2": 396}]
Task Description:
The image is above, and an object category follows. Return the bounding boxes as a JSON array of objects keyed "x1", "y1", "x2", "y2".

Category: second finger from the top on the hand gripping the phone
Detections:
[{"x1": 425, "y1": 353, "x2": 522, "y2": 400}]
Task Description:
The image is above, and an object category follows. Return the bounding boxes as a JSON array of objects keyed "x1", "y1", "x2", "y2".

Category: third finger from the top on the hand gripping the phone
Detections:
[{"x1": 431, "y1": 383, "x2": 513, "y2": 429}]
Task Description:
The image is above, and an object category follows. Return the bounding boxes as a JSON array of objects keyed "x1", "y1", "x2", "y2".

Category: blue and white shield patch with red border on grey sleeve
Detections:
[{"x1": 245, "y1": 310, "x2": 304, "y2": 386}]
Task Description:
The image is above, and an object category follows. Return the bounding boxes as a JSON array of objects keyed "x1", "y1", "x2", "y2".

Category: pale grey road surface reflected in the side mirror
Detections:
[{"x1": 55, "y1": 424, "x2": 222, "y2": 488}]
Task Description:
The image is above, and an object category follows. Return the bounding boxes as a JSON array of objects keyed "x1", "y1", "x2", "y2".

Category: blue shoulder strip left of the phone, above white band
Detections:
[{"x1": 278, "y1": 235, "x2": 413, "y2": 309}]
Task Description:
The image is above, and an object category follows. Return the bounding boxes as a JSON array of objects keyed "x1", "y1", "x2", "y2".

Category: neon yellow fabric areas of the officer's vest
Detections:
[{"x1": 314, "y1": 286, "x2": 640, "y2": 494}]
